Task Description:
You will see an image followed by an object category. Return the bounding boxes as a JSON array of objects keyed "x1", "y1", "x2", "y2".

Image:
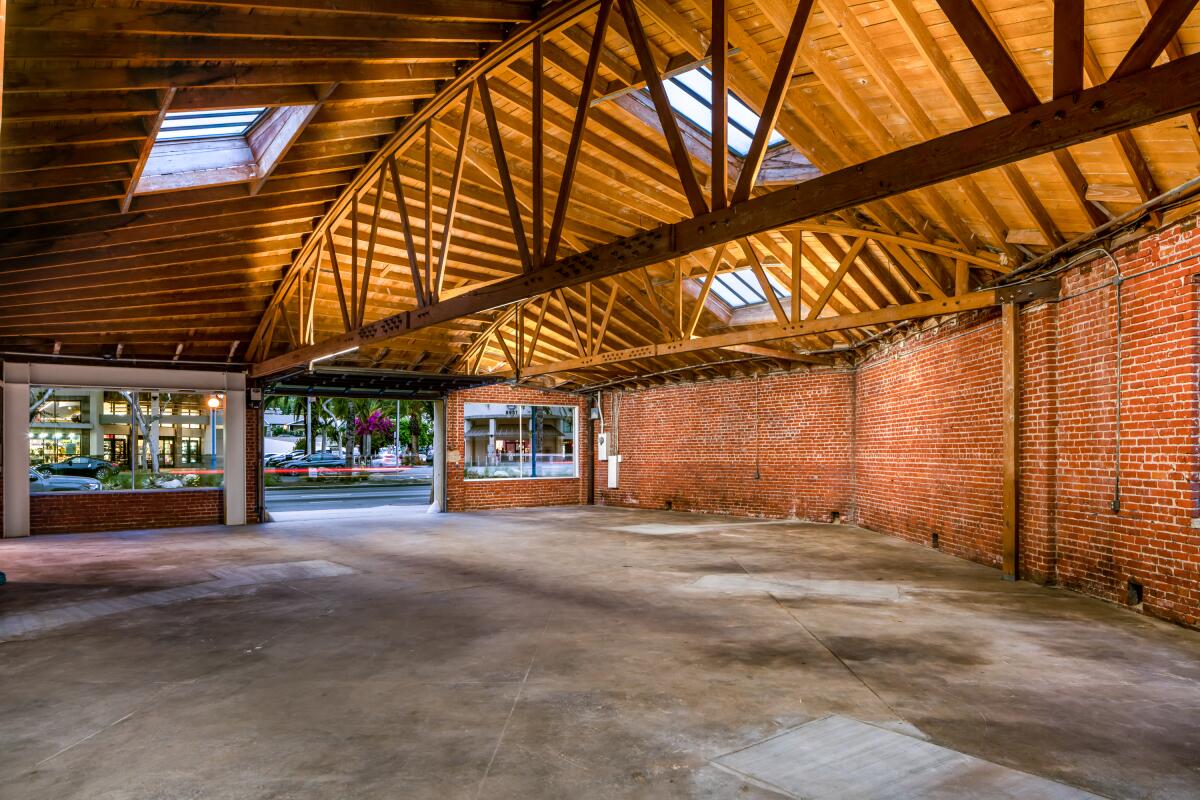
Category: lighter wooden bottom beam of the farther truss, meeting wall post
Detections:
[{"x1": 521, "y1": 279, "x2": 1058, "y2": 378}]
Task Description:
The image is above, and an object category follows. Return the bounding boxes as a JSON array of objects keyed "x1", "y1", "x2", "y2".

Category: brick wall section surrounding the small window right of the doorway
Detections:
[{"x1": 446, "y1": 385, "x2": 592, "y2": 511}]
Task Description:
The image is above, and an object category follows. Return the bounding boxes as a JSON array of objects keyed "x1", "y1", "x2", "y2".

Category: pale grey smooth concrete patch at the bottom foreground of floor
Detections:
[{"x1": 713, "y1": 715, "x2": 1099, "y2": 800}]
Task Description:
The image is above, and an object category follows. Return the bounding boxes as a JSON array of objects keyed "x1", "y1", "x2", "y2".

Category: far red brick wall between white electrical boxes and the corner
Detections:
[{"x1": 595, "y1": 372, "x2": 853, "y2": 521}]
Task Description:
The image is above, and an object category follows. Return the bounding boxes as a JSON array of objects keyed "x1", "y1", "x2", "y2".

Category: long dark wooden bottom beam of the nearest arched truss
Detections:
[{"x1": 251, "y1": 55, "x2": 1200, "y2": 377}]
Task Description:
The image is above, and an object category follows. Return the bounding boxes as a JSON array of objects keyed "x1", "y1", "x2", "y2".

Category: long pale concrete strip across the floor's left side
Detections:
[{"x1": 0, "y1": 560, "x2": 355, "y2": 640}]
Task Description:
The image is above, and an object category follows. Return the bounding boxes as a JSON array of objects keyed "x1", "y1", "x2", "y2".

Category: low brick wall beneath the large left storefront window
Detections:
[{"x1": 29, "y1": 489, "x2": 224, "y2": 534}]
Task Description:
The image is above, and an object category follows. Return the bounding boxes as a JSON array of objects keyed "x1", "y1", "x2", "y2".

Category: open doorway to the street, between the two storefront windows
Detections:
[{"x1": 263, "y1": 392, "x2": 440, "y2": 519}]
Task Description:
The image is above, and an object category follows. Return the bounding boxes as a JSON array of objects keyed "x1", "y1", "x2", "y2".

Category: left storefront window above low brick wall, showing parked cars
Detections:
[{"x1": 29, "y1": 386, "x2": 224, "y2": 492}]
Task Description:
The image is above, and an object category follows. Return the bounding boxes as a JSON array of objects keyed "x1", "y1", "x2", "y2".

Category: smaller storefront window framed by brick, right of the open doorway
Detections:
[{"x1": 463, "y1": 403, "x2": 576, "y2": 480}]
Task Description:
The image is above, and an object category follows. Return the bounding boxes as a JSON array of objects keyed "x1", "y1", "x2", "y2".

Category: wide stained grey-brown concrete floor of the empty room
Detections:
[{"x1": 0, "y1": 507, "x2": 1200, "y2": 800}]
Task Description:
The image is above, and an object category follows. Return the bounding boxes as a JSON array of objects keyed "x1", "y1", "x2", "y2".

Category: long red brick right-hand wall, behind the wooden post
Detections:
[{"x1": 856, "y1": 217, "x2": 1200, "y2": 626}]
